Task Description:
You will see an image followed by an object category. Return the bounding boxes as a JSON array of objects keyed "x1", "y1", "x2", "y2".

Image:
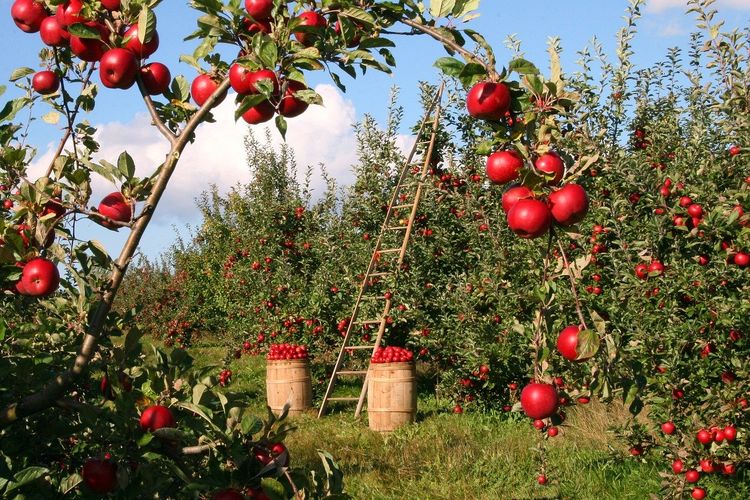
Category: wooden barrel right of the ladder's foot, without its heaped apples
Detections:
[{"x1": 367, "y1": 363, "x2": 417, "y2": 432}]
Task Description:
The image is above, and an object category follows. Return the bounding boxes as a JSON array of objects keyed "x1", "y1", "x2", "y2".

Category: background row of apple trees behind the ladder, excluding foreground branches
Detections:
[{"x1": 123, "y1": 2, "x2": 750, "y2": 498}]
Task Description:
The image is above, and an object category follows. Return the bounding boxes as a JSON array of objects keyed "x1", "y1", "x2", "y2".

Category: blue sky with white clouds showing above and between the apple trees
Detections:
[{"x1": 0, "y1": 0, "x2": 750, "y2": 256}]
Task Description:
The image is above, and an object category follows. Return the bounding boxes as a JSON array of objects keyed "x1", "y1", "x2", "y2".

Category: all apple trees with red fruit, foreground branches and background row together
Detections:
[{"x1": 0, "y1": 0, "x2": 750, "y2": 500}]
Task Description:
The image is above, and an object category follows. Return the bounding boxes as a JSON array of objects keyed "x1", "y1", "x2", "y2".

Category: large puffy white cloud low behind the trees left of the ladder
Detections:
[{"x1": 35, "y1": 84, "x2": 356, "y2": 224}]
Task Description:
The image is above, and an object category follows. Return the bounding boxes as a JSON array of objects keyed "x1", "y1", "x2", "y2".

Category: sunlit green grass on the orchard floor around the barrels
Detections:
[{"x1": 191, "y1": 348, "x2": 659, "y2": 499}]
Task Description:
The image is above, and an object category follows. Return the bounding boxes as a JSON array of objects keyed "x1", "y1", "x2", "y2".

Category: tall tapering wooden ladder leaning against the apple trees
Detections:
[{"x1": 318, "y1": 83, "x2": 445, "y2": 418}]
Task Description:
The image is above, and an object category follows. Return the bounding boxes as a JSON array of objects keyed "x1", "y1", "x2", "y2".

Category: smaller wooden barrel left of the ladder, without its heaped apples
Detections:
[{"x1": 266, "y1": 359, "x2": 312, "y2": 415}]
